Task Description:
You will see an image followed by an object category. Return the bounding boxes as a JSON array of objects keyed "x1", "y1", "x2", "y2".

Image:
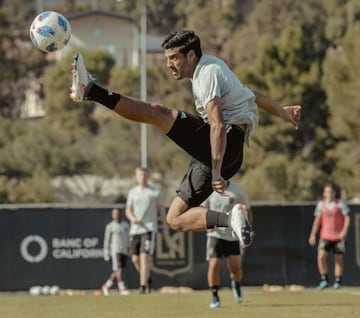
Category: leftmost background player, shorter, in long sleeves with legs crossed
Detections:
[{"x1": 102, "y1": 209, "x2": 129, "y2": 296}]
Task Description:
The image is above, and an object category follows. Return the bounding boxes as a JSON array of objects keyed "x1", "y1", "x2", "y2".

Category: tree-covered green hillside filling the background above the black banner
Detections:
[{"x1": 0, "y1": 0, "x2": 360, "y2": 203}]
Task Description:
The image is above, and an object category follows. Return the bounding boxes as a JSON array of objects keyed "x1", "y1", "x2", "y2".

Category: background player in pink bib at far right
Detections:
[{"x1": 309, "y1": 184, "x2": 350, "y2": 290}]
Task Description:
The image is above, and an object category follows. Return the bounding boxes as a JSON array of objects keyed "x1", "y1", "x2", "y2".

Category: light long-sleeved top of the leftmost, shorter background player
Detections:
[{"x1": 104, "y1": 221, "x2": 129, "y2": 256}]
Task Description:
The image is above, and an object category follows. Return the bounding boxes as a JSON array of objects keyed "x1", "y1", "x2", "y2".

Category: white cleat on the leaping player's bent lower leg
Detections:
[{"x1": 230, "y1": 203, "x2": 254, "y2": 247}]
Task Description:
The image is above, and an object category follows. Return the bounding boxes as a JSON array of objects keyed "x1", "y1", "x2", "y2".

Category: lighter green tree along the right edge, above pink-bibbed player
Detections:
[{"x1": 323, "y1": 1, "x2": 360, "y2": 196}]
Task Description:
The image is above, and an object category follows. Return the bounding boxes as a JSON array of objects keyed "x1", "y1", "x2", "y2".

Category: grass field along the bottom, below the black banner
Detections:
[{"x1": 0, "y1": 287, "x2": 360, "y2": 318}]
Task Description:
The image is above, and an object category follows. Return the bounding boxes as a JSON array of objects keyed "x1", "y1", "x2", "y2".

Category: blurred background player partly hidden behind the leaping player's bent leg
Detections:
[{"x1": 203, "y1": 181, "x2": 253, "y2": 308}]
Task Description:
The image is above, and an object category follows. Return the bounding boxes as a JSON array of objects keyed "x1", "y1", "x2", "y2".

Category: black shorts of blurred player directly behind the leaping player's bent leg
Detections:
[{"x1": 206, "y1": 236, "x2": 241, "y2": 260}]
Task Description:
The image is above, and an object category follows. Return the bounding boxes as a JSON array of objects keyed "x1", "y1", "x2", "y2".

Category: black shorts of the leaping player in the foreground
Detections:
[{"x1": 167, "y1": 112, "x2": 244, "y2": 207}]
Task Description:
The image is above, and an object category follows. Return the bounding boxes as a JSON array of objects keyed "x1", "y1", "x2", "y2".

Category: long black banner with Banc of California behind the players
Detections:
[{"x1": 0, "y1": 205, "x2": 360, "y2": 291}]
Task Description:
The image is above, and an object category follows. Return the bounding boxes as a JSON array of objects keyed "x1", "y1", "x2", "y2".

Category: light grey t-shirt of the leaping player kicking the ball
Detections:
[{"x1": 192, "y1": 55, "x2": 258, "y2": 142}]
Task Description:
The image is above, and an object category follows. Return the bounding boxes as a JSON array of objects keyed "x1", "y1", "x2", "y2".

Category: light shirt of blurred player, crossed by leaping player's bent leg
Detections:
[{"x1": 203, "y1": 182, "x2": 250, "y2": 241}]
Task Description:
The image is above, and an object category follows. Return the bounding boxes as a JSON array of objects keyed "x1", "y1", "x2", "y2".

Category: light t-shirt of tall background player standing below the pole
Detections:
[{"x1": 126, "y1": 186, "x2": 161, "y2": 235}]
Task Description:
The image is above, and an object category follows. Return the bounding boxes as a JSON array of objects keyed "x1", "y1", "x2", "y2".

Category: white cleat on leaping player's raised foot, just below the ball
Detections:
[{"x1": 70, "y1": 52, "x2": 94, "y2": 102}]
